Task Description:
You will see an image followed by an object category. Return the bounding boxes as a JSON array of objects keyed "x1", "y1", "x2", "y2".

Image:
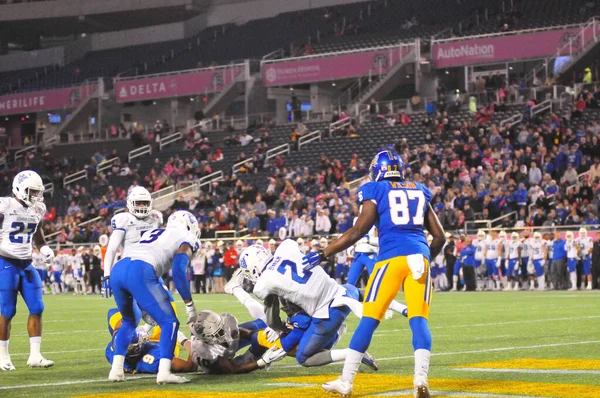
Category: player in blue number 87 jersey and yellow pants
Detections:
[{"x1": 300, "y1": 151, "x2": 446, "y2": 398}]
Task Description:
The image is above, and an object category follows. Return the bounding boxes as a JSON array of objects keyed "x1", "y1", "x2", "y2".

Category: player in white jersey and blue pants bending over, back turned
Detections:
[{"x1": 108, "y1": 211, "x2": 200, "y2": 384}]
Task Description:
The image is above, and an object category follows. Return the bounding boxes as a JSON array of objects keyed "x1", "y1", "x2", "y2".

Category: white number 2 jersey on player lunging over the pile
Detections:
[{"x1": 254, "y1": 239, "x2": 346, "y2": 319}]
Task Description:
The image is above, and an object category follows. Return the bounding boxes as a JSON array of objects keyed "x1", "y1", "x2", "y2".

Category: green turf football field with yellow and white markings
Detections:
[{"x1": 0, "y1": 292, "x2": 600, "y2": 398}]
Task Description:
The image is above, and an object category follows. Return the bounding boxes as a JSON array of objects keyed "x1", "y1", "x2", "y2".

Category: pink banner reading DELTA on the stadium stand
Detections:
[{"x1": 115, "y1": 66, "x2": 244, "y2": 102}]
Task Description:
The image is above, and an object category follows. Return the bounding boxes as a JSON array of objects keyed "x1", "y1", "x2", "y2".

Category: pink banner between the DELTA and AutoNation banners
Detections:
[{"x1": 262, "y1": 46, "x2": 412, "y2": 86}]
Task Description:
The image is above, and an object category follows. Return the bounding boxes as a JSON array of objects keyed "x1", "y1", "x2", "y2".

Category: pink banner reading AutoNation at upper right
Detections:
[{"x1": 432, "y1": 25, "x2": 594, "y2": 68}]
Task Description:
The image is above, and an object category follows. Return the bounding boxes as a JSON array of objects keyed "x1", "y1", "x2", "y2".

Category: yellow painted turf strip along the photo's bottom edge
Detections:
[{"x1": 81, "y1": 374, "x2": 600, "y2": 398}]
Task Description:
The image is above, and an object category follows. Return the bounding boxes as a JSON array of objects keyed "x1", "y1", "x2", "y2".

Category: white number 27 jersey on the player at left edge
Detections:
[{"x1": 0, "y1": 198, "x2": 46, "y2": 260}]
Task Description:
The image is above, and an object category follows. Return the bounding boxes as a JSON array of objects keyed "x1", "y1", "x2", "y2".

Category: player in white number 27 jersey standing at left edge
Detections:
[{"x1": 0, "y1": 170, "x2": 54, "y2": 370}]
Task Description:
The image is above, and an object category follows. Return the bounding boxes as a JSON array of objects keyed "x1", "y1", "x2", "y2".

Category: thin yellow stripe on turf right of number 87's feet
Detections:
[{"x1": 455, "y1": 358, "x2": 600, "y2": 370}]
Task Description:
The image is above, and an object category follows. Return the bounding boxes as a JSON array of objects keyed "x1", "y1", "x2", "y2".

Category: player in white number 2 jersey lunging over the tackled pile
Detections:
[{"x1": 239, "y1": 239, "x2": 376, "y2": 368}]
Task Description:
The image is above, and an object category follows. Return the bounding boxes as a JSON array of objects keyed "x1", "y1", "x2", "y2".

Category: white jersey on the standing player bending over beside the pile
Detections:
[{"x1": 123, "y1": 228, "x2": 200, "y2": 276}]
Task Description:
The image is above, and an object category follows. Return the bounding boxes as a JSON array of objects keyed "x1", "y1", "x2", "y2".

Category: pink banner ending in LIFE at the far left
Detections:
[{"x1": 0, "y1": 85, "x2": 96, "y2": 115}]
